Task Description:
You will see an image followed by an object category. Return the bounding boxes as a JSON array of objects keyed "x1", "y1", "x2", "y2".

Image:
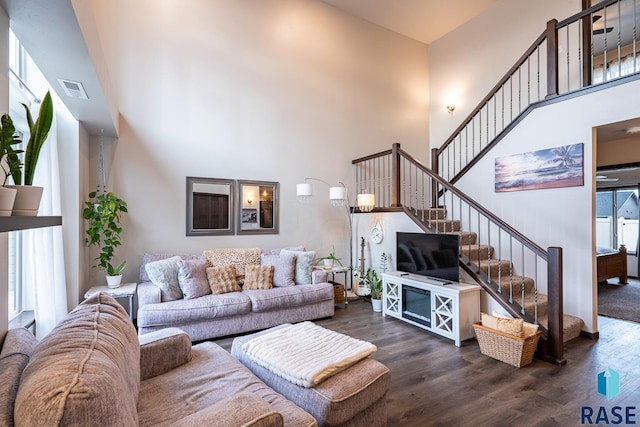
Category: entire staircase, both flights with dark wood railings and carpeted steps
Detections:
[{"x1": 352, "y1": 0, "x2": 640, "y2": 365}]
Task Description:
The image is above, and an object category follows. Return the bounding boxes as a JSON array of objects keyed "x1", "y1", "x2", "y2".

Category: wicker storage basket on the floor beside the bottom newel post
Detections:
[{"x1": 473, "y1": 322, "x2": 542, "y2": 368}]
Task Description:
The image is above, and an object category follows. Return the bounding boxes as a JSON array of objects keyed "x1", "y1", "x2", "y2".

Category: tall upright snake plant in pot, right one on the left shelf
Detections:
[{"x1": 5, "y1": 92, "x2": 53, "y2": 216}]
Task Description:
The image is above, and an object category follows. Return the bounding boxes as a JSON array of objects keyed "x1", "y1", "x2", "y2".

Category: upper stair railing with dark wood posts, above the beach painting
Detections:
[{"x1": 431, "y1": 0, "x2": 640, "y2": 184}]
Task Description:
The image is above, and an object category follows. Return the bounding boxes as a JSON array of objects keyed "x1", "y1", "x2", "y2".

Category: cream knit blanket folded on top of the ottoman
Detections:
[{"x1": 242, "y1": 322, "x2": 377, "y2": 388}]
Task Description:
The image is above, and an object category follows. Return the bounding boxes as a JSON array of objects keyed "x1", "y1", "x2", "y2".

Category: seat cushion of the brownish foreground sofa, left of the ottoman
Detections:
[{"x1": 138, "y1": 342, "x2": 317, "y2": 427}]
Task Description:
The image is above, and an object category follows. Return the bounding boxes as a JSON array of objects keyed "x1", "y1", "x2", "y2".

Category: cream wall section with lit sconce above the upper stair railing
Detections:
[{"x1": 429, "y1": 0, "x2": 581, "y2": 148}]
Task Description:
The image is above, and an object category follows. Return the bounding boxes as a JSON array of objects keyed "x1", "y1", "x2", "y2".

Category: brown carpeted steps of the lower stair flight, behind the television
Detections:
[{"x1": 418, "y1": 208, "x2": 584, "y2": 342}]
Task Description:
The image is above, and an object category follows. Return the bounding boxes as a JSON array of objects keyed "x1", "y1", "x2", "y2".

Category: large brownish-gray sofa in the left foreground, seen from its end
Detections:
[{"x1": 0, "y1": 293, "x2": 317, "y2": 427}]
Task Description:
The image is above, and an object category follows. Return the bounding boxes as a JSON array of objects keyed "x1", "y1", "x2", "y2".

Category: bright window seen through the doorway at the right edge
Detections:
[{"x1": 596, "y1": 188, "x2": 639, "y2": 253}]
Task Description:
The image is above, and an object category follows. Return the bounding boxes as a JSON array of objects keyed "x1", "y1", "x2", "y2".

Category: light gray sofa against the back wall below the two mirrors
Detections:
[{"x1": 137, "y1": 248, "x2": 335, "y2": 341}]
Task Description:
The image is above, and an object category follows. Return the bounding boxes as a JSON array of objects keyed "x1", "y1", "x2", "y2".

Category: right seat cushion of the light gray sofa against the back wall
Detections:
[{"x1": 242, "y1": 283, "x2": 333, "y2": 313}]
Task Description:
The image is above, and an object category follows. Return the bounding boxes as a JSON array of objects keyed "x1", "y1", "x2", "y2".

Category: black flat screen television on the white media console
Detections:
[{"x1": 396, "y1": 232, "x2": 460, "y2": 282}]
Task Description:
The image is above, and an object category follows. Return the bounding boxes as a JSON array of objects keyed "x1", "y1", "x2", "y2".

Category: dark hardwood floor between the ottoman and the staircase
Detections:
[{"x1": 216, "y1": 300, "x2": 640, "y2": 427}]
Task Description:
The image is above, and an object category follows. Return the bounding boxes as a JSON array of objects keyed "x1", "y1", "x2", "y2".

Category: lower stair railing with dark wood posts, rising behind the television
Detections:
[{"x1": 352, "y1": 143, "x2": 564, "y2": 364}]
